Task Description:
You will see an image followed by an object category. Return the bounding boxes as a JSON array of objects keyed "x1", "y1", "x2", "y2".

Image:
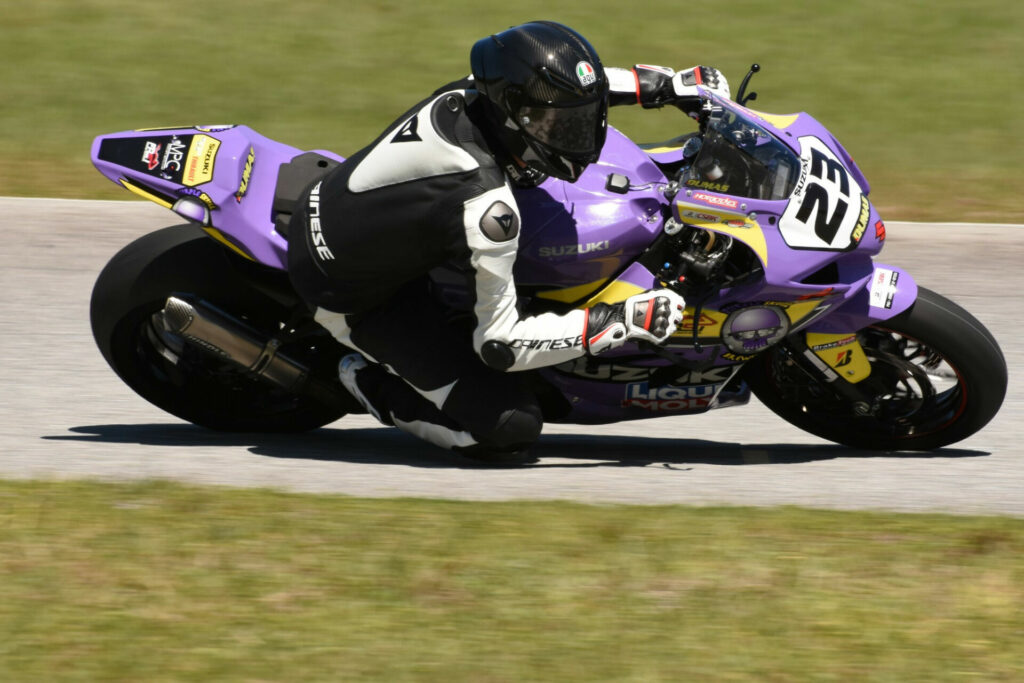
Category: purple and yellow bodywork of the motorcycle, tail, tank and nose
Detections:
[{"x1": 92, "y1": 90, "x2": 916, "y2": 424}]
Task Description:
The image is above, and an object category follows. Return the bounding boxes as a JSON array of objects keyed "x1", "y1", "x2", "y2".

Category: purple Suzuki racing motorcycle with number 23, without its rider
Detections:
[{"x1": 90, "y1": 65, "x2": 1007, "y2": 451}]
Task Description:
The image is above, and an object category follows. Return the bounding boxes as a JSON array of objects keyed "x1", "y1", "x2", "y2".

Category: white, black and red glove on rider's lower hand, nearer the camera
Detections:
[{"x1": 583, "y1": 289, "x2": 686, "y2": 355}]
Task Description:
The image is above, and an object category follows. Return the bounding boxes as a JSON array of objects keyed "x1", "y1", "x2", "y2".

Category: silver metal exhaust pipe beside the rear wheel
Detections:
[{"x1": 161, "y1": 296, "x2": 309, "y2": 392}]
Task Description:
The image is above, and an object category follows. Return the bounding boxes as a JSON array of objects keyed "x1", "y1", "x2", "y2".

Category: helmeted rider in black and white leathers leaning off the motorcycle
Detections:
[{"x1": 289, "y1": 22, "x2": 728, "y2": 457}]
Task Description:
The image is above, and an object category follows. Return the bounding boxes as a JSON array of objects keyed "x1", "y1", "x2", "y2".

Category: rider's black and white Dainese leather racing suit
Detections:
[{"x1": 289, "y1": 68, "x2": 724, "y2": 452}]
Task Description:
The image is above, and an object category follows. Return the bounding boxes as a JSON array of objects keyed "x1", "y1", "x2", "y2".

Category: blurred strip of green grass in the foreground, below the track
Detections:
[{"x1": 0, "y1": 482, "x2": 1024, "y2": 682}]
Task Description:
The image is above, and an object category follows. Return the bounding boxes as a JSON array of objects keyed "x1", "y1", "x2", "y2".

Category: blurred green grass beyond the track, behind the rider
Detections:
[{"x1": 0, "y1": 0, "x2": 1024, "y2": 222}]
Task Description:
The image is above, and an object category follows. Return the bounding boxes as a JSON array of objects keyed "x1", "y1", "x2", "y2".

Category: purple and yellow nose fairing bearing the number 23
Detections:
[{"x1": 673, "y1": 96, "x2": 886, "y2": 311}]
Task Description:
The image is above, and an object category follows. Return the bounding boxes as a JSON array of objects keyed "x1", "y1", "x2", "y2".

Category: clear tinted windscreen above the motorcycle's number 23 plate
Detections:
[{"x1": 682, "y1": 110, "x2": 800, "y2": 200}]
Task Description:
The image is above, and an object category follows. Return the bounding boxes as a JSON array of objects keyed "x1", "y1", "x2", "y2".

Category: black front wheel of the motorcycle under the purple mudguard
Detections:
[{"x1": 746, "y1": 288, "x2": 1007, "y2": 451}]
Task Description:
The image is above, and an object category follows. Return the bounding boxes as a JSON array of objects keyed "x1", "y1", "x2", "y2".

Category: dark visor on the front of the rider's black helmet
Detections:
[{"x1": 517, "y1": 99, "x2": 604, "y2": 155}]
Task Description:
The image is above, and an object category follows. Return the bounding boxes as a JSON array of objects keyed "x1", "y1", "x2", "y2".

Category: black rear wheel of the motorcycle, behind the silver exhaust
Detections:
[{"x1": 90, "y1": 225, "x2": 344, "y2": 432}]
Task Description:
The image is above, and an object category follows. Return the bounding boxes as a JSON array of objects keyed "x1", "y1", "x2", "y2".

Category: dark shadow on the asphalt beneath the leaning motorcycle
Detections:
[{"x1": 51, "y1": 424, "x2": 991, "y2": 469}]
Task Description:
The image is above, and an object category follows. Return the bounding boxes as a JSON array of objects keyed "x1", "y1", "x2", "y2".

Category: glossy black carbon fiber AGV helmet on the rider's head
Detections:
[{"x1": 470, "y1": 22, "x2": 608, "y2": 182}]
